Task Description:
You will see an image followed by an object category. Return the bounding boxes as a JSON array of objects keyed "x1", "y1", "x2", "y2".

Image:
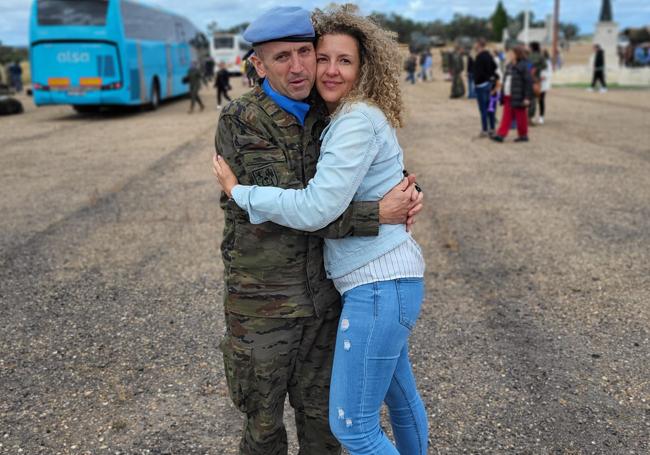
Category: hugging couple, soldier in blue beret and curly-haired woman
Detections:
[{"x1": 213, "y1": 7, "x2": 428, "y2": 455}]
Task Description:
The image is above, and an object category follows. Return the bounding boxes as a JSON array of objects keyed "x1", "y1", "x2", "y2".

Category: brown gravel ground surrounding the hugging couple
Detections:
[{"x1": 0, "y1": 82, "x2": 650, "y2": 454}]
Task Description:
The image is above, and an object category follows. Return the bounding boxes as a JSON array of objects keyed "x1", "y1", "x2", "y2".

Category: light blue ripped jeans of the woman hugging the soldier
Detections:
[{"x1": 329, "y1": 278, "x2": 428, "y2": 455}]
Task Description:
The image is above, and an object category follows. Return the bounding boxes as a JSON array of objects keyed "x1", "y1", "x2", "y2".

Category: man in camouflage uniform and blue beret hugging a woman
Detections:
[{"x1": 215, "y1": 8, "x2": 422, "y2": 455}]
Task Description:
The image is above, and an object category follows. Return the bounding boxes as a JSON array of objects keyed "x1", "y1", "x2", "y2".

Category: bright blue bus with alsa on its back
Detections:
[{"x1": 30, "y1": 0, "x2": 209, "y2": 112}]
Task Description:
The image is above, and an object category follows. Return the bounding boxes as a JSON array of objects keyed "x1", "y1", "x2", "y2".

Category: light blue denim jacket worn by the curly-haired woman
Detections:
[{"x1": 232, "y1": 102, "x2": 409, "y2": 278}]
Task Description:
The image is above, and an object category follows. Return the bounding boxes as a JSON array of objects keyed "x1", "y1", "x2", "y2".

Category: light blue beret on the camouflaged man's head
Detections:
[{"x1": 244, "y1": 6, "x2": 316, "y2": 44}]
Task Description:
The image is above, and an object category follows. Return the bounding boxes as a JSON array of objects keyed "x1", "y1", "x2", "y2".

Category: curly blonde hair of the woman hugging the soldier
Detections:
[{"x1": 312, "y1": 5, "x2": 404, "y2": 128}]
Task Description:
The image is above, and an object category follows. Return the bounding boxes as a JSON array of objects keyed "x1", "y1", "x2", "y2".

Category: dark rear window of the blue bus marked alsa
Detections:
[{"x1": 37, "y1": 0, "x2": 108, "y2": 26}]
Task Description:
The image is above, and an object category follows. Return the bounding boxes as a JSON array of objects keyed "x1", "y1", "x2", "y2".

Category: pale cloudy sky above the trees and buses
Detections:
[{"x1": 0, "y1": 0, "x2": 650, "y2": 45}]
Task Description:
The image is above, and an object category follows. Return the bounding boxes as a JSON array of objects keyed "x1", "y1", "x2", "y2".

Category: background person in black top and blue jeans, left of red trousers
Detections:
[{"x1": 472, "y1": 38, "x2": 499, "y2": 137}]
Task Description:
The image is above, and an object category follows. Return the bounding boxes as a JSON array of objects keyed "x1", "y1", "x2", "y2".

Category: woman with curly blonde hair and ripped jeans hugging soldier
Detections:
[{"x1": 214, "y1": 8, "x2": 428, "y2": 455}]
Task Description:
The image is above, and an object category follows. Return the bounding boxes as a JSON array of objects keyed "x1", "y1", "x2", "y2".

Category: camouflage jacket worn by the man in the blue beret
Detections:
[{"x1": 215, "y1": 86, "x2": 379, "y2": 318}]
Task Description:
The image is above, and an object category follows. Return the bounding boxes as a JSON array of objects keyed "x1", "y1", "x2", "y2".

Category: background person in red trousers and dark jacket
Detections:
[{"x1": 491, "y1": 46, "x2": 533, "y2": 142}]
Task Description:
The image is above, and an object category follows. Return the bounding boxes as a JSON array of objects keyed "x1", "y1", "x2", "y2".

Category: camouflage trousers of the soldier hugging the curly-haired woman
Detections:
[{"x1": 220, "y1": 302, "x2": 341, "y2": 455}]
